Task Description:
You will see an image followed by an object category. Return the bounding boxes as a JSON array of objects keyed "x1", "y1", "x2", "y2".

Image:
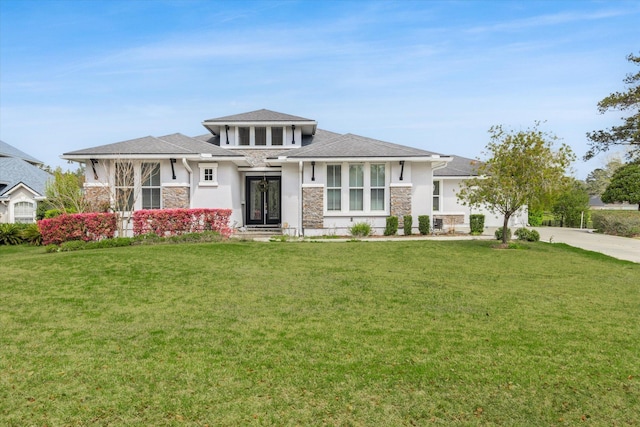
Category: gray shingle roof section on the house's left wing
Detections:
[{"x1": 63, "y1": 133, "x2": 237, "y2": 157}]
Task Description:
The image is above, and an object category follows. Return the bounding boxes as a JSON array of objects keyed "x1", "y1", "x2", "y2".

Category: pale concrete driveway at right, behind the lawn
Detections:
[{"x1": 535, "y1": 227, "x2": 640, "y2": 263}]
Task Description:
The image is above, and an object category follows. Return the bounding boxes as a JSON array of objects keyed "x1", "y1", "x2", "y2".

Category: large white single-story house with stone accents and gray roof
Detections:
[{"x1": 62, "y1": 110, "x2": 526, "y2": 235}]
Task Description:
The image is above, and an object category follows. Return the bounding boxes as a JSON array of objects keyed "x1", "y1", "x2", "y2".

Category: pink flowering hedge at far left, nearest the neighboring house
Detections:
[{"x1": 38, "y1": 212, "x2": 117, "y2": 245}]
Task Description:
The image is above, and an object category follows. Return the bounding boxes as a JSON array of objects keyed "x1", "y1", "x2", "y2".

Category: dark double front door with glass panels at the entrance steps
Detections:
[{"x1": 246, "y1": 176, "x2": 280, "y2": 225}]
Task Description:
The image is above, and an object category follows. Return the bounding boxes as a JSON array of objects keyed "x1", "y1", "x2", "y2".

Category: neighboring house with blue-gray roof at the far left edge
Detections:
[{"x1": 0, "y1": 141, "x2": 51, "y2": 223}]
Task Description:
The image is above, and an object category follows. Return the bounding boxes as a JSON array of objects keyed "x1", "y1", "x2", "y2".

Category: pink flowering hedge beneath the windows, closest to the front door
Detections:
[{"x1": 133, "y1": 209, "x2": 233, "y2": 237}]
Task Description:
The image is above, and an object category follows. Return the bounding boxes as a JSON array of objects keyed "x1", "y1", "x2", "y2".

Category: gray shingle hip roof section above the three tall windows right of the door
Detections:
[{"x1": 288, "y1": 133, "x2": 437, "y2": 158}]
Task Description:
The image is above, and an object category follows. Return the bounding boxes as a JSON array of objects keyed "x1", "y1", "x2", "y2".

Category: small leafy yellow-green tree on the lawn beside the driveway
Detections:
[{"x1": 457, "y1": 123, "x2": 575, "y2": 243}]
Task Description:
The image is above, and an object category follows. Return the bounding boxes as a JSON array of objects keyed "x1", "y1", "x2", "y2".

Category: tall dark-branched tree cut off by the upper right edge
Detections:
[{"x1": 584, "y1": 54, "x2": 640, "y2": 160}]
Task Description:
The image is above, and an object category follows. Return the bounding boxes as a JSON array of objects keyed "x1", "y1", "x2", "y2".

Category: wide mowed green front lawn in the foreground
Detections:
[{"x1": 0, "y1": 241, "x2": 640, "y2": 426}]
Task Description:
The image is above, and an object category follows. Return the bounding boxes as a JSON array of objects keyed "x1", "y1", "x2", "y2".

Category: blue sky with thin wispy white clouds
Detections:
[{"x1": 0, "y1": 0, "x2": 640, "y2": 178}]
